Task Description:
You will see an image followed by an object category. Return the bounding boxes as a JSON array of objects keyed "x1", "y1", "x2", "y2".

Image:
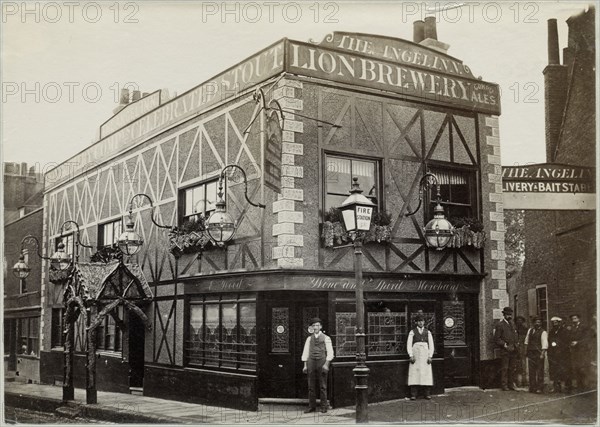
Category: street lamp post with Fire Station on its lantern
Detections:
[{"x1": 339, "y1": 177, "x2": 375, "y2": 423}]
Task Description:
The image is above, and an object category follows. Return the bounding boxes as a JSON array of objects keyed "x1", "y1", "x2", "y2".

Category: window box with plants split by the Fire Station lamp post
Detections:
[{"x1": 321, "y1": 208, "x2": 392, "y2": 248}]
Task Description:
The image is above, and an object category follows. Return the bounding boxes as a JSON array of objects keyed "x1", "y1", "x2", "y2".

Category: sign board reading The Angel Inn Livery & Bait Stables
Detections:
[{"x1": 502, "y1": 163, "x2": 596, "y2": 210}]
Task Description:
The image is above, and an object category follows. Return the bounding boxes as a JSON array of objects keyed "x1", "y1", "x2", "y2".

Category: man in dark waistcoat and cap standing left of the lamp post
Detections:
[{"x1": 302, "y1": 317, "x2": 334, "y2": 413}]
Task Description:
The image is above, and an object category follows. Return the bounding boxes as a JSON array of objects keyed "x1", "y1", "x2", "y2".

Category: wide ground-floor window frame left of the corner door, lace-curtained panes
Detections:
[{"x1": 184, "y1": 294, "x2": 258, "y2": 373}]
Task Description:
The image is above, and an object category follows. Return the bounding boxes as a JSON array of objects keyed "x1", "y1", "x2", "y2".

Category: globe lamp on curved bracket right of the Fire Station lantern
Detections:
[{"x1": 406, "y1": 172, "x2": 454, "y2": 251}]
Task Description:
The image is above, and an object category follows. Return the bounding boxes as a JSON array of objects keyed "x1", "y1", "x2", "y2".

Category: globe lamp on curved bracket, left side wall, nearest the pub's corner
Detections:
[{"x1": 206, "y1": 164, "x2": 265, "y2": 246}]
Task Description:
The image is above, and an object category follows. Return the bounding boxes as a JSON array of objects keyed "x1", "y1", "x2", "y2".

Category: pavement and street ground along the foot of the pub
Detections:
[{"x1": 4, "y1": 382, "x2": 598, "y2": 425}]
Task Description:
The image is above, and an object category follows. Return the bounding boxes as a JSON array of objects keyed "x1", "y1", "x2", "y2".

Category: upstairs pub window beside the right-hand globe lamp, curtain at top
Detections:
[{"x1": 428, "y1": 165, "x2": 478, "y2": 222}]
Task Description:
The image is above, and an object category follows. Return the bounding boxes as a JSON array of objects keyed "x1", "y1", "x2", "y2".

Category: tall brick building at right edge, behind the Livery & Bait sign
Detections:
[{"x1": 509, "y1": 7, "x2": 597, "y2": 328}]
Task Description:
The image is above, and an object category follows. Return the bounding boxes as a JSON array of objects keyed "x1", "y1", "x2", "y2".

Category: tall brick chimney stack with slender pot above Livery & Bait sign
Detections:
[{"x1": 543, "y1": 19, "x2": 568, "y2": 163}]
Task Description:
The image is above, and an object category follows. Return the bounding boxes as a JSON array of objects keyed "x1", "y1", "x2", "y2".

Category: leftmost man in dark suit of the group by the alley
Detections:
[{"x1": 494, "y1": 307, "x2": 519, "y2": 391}]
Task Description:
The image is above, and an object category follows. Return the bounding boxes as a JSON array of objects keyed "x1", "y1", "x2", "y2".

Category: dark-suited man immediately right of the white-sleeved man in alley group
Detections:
[{"x1": 548, "y1": 316, "x2": 571, "y2": 393}]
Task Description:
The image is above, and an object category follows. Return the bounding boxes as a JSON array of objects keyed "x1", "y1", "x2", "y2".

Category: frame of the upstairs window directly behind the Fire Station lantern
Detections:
[{"x1": 322, "y1": 150, "x2": 385, "y2": 215}]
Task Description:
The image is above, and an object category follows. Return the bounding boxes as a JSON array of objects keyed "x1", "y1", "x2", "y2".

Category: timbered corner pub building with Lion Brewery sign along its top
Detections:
[{"x1": 41, "y1": 20, "x2": 508, "y2": 410}]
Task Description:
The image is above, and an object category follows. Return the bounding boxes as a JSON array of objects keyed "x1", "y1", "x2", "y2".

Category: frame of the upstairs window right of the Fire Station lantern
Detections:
[{"x1": 425, "y1": 161, "x2": 481, "y2": 221}]
